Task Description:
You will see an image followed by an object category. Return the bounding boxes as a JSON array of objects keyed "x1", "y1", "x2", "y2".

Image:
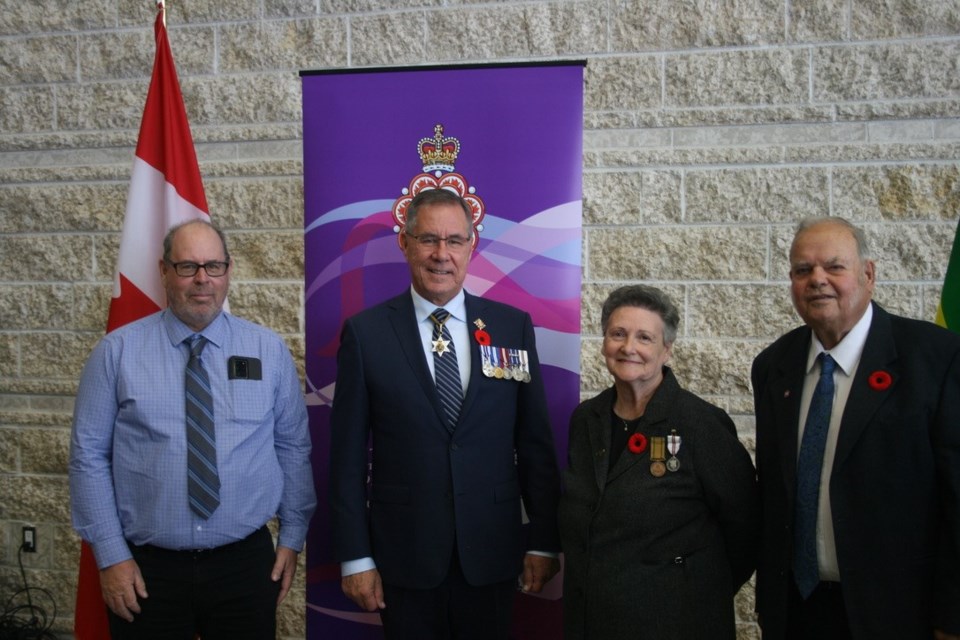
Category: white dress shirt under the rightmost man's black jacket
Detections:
[{"x1": 797, "y1": 305, "x2": 873, "y2": 582}]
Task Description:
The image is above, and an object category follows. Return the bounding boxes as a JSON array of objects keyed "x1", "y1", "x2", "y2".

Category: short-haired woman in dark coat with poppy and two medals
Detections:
[{"x1": 559, "y1": 285, "x2": 760, "y2": 640}]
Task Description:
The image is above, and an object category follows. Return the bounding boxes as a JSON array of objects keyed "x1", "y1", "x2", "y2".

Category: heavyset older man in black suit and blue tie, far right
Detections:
[{"x1": 752, "y1": 218, "x2": 960, "y2": 640}]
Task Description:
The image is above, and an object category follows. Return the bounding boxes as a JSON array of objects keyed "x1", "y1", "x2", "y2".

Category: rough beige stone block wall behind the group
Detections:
[{"x1": 0, "y1": 0, "x2": 960, "y2": 638}]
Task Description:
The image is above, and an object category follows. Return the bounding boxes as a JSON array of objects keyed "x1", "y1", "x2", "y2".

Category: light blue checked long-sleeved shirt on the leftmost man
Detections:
[{"x1": 70, "y1": 310, "x2": 316, "y2": 569}]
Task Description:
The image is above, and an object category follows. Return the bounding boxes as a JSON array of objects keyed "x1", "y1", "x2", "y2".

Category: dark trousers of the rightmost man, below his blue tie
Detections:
[{"x1": 787, "y1": 575, "x2": 853, "y2": 640}]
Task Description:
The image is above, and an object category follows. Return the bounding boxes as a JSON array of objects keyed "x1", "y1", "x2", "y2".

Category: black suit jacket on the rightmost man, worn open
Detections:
[{"x1": 752, "y1": 304, "x2": 960, "y2": 640}]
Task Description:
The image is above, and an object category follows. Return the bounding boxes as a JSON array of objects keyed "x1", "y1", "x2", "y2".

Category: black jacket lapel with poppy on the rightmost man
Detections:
[{"x1": 833, "y1": 304, "x2": 900, "y2": 469}]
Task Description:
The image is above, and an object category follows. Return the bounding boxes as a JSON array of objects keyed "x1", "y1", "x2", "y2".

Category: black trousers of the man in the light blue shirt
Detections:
[{"x1": 108, "y1": 527, "x2": 280, "y2": 640}]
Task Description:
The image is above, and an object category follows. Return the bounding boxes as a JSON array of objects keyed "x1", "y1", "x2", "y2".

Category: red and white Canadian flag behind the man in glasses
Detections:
[{"x1": 73, "y1": 0, "x2": 210, "y2": 640}]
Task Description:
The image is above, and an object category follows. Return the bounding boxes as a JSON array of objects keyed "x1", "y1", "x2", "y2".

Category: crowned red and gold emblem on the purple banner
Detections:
[{"x1": 392, "y1": 123, "x2": 486, "y2": 249}]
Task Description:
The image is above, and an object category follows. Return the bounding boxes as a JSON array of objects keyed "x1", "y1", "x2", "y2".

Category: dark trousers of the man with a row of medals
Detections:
[{"x1": 380, "y1": 552, "x2": 517, "y2": 640}]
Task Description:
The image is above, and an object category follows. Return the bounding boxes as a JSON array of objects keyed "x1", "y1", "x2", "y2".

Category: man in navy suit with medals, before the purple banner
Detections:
[{"x1": 330, "y1": 189, "x2": 559, "y2": 640}]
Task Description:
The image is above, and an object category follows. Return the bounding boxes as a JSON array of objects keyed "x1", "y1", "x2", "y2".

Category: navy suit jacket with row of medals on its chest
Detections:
[{"x1": 330, "y1": 292, "x2": 559, "y2": 589}]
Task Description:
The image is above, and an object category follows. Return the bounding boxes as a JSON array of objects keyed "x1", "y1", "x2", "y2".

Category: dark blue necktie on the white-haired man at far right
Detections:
[{"x1": 793, "y1": 353, "x2": 837, "y2": 600}]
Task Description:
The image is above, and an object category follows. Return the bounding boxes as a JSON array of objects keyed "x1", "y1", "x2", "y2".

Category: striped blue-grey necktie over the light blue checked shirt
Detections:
[{"x1": 185, "y1": 335, "x2": 220, "y2": 520}]
